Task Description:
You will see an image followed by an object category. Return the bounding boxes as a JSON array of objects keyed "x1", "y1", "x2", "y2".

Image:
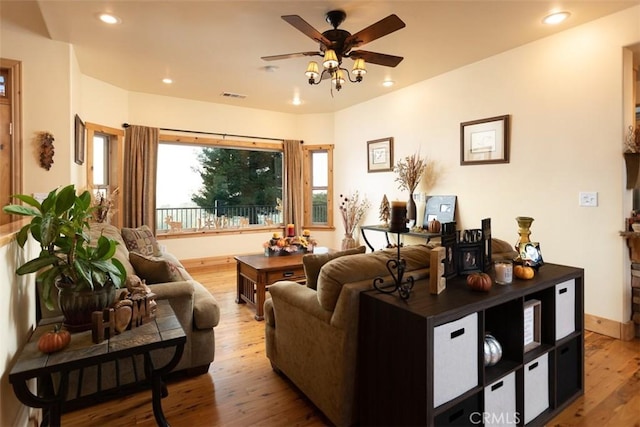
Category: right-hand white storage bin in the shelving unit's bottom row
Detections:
[{"x1": 524, "y1": 353, "x2": 549, "y2": 424}]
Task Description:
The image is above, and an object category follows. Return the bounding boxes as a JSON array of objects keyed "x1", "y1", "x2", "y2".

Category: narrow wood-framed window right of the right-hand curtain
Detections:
[{"x1": 303, "y1": 145, "x2": 333, "y2": 228}]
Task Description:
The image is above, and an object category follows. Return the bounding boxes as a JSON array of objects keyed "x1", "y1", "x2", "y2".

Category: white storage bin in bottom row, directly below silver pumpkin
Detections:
[{"x1": 484, "y1": 372, "x2": 520, "y2": 426}]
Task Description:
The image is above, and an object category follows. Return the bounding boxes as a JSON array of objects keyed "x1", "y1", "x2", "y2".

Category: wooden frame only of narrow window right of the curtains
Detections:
[{"x1": 302, "y1": 144, "x2": 335, "y2": 230}]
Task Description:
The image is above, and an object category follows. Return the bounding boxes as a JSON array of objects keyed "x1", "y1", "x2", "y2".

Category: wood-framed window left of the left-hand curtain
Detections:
[{"x1": 85, "y1": 123, "x2": 124, "y2": 226}]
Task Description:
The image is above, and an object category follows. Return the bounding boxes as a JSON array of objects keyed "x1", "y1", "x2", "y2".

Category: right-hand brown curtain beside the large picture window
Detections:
[{"x1": 283, "y1": 140, "x2": 303, "y2": 235}]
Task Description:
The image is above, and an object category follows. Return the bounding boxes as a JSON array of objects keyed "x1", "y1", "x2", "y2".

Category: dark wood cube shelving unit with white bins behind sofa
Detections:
[{"x1": 357, "y1": 264, "x2": 584, "y2": 426}]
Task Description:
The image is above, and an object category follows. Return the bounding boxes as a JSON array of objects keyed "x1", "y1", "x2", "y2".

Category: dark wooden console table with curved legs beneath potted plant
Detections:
[{"x1": 9, "y1": 300, "x2": 187, "y2": 426}]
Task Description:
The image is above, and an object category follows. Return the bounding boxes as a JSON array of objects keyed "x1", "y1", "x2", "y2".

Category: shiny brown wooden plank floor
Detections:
[{"x1": 62, "y1": 265, "x2": 640, "y2": 427}]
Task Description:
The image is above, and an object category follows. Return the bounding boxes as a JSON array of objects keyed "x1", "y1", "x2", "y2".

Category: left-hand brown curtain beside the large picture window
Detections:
[{"x1": 122, "y1": 125, "x2": 159, "y2": 232}]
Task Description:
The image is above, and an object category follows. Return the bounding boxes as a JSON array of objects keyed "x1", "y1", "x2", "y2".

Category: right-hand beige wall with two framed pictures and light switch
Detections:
[{"x1": 335, "y1": 8, "x2": 640, "y2": 322}]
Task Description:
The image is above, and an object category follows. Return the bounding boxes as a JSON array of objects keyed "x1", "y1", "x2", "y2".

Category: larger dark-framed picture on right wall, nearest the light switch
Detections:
[{"x1": 460, "y1": 115, "x2": 509, "y2": 165}]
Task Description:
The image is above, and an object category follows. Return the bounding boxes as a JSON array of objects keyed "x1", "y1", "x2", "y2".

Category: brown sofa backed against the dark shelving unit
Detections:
[{"x1": 264, "y1": 239, "x2": 516, "y2": 426}]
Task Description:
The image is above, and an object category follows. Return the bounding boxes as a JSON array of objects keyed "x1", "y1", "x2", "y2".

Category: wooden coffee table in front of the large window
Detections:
[{"x1": 234, "y1": 248, "x2": 329, "y2": 320}]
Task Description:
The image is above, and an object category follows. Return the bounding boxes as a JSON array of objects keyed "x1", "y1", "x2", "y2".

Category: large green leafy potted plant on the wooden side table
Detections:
[{"x1": 3, "y1": 185, "x2": 126, "y2": 331}]
